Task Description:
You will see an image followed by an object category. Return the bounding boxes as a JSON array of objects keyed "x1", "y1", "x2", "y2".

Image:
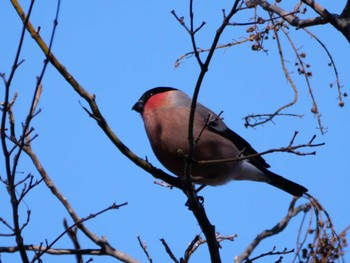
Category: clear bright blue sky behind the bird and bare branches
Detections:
[{"x1": 0, "y1": 1, "x2": 350, "y2": 262}]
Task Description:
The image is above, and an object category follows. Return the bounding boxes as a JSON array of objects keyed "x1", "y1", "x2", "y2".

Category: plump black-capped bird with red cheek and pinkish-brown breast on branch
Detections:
[{"x1": 132, "y1": 87, "x2": 308, "y2": 197}]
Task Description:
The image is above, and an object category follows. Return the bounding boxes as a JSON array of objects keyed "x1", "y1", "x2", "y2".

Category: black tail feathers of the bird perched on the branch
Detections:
[{"x1": 264, "y1": 169, "x2": 308, "y2": 196}]
